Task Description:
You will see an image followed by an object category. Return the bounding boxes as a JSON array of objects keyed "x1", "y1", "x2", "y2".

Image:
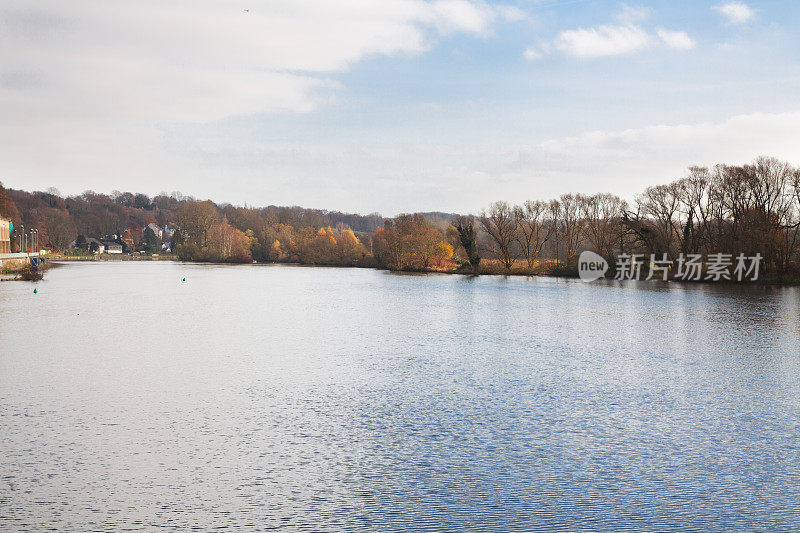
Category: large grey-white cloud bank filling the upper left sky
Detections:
[{"x1": 0, "y1": 0, "x2": 518, "y2": 122}]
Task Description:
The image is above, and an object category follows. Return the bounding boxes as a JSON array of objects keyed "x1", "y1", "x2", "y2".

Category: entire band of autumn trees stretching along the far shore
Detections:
[{"x1": 0, "y1": 157, "x2": 800, "y2": 275}]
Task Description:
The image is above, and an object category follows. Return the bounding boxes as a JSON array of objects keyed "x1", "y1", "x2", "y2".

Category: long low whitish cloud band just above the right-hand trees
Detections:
[{"x1": 243, "y1": 113, "x2": 800, "y2": 214}]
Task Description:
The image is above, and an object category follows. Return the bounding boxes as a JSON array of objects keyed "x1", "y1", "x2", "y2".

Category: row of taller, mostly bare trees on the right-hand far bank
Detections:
[{"x1": 466, "y1": 157, "x2": 800, "y2": 276}]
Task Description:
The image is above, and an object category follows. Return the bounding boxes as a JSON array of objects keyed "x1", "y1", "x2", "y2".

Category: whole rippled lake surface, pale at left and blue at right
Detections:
[{"x1": 0, "y1": 262, "x2": 800, "y2": 531}]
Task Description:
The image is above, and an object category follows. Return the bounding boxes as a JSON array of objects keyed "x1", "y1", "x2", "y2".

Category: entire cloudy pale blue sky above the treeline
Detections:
[{"x1": 0, "y1": 0, "x2": 800, "y2": 216}]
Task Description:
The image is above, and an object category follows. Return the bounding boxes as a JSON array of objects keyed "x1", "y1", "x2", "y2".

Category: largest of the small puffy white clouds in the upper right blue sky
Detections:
[{"x1": 555, "y1": 25, "x2": 652, "y2": 59}]
